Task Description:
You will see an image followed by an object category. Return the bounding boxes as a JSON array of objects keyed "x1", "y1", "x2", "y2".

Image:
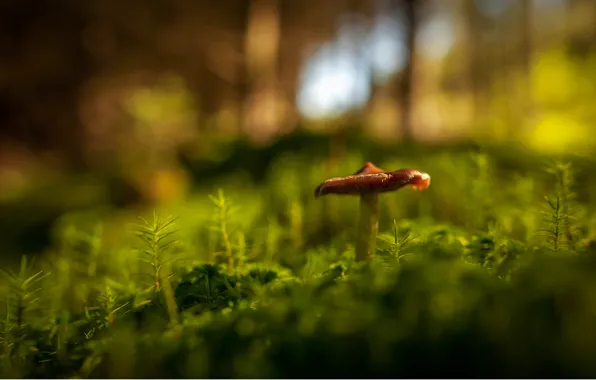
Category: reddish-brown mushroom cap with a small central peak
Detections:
[{"x1": 315, "y1": 162, "x2": 430, "y2": 198}]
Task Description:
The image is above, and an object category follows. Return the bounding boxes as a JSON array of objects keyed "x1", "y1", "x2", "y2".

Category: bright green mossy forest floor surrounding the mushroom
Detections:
[{"x1": 0, "y1": 144, "x2": 596, "y2": 377}]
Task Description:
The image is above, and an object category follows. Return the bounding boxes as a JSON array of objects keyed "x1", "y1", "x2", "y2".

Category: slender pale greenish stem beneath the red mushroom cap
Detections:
[{"x1": 356, "y1": 193, "x2": 379, "y2": 261}]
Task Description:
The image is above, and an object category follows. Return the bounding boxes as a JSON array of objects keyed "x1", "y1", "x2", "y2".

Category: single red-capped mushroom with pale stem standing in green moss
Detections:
[{"x1": 315, "y1": 162, "x2": 430, "y2": 261}]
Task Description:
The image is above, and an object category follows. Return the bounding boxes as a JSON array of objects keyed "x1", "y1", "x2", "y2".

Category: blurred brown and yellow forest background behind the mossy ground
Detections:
[{"x1": 0, "y1": 0, "x2": 596, "y2": 262}]
